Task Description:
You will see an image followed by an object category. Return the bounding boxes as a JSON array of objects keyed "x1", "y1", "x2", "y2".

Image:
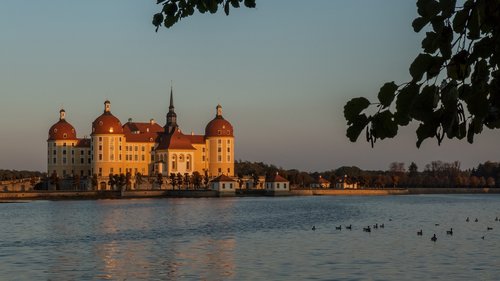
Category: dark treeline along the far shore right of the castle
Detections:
[{"x1": 235, "y1": 160, "x2": 500, "y2": 188}]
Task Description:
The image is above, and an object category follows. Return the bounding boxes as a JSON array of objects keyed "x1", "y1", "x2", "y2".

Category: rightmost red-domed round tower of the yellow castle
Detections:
[{"x1": 205, "y1": 104, "x2": 234, "y2": 176}]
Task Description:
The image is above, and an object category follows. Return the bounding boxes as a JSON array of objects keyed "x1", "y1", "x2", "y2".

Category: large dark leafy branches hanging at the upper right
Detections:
[{"x1": 344, "y1": 0, "x2": 500, "y2": 147}]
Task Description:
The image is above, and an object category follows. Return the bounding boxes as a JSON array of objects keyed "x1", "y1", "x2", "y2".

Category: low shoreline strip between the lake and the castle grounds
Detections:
[{"x1": 0, "y1": 188, "x2": 500, "y2": 200}]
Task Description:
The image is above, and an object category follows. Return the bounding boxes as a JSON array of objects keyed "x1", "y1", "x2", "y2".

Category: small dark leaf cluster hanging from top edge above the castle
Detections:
[{"x1": 153, "y1": 0, "x2": 255, "y2": 32}]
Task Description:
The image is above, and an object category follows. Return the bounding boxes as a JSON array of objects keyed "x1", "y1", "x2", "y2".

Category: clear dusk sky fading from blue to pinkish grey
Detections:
[{"x1": 0, "y1": 0, "x2": 500, "y2": 171}]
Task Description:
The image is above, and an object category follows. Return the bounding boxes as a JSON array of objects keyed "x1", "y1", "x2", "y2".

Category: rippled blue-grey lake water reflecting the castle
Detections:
[{"x1": 0, "y1": 195, "x2": 500, "y2": 280}]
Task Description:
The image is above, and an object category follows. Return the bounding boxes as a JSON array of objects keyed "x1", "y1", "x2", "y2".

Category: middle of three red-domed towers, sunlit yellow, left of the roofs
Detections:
[{"x1": 91, "y1": 100, "x2": 125, "y2": 182}]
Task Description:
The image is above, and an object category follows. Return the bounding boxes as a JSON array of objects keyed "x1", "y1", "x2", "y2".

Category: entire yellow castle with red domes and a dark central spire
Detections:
[{"x1": 47, "y1": 89, "x2": 234, "y2": 189}]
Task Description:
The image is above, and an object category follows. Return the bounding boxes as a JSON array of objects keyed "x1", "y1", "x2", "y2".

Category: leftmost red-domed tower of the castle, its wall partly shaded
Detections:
[{"x1": 47, "y1": 109, "x2": 78, "y2": 177}]
